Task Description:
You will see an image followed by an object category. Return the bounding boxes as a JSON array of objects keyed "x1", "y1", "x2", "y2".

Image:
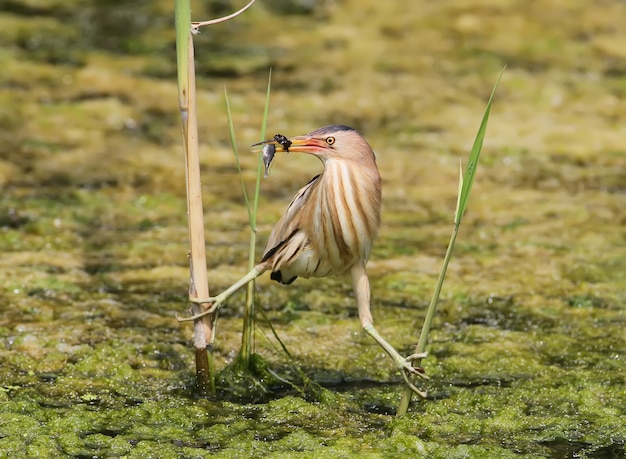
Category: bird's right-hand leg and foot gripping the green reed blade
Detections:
[{"x1": 350, "y1": 263, "x2": 428, "y2": 398}]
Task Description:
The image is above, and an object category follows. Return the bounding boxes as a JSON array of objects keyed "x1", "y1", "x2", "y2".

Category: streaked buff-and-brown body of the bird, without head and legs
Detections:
[{"x1": 262, "y1": 160, "x2": 381, "y2": 283}]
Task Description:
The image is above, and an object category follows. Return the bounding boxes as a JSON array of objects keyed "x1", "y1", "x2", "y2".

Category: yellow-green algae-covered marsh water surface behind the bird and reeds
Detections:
[{"x1": 0, "y1": 0, "x2": 626, "y2": 458}]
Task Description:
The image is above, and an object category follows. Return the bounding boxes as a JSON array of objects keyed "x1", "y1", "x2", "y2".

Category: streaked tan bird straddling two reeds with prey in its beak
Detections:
[{"x1": 179, "y1": 125, "x2": 428, "y2": 396}]
